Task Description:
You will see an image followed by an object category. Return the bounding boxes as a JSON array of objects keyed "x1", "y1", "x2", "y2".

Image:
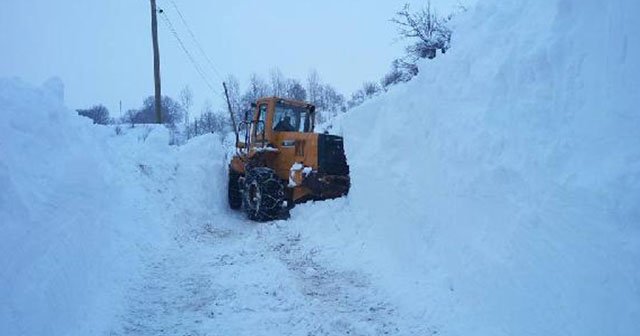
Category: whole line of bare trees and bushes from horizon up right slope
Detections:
[{"x1": 77, "y1": 2, "x2": 466, "y2": 143}]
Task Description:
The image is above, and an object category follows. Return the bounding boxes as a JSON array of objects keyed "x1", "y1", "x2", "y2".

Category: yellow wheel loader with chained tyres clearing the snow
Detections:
[{"x1": 228, "y1": 97, "x2": 350, "y2": 221}]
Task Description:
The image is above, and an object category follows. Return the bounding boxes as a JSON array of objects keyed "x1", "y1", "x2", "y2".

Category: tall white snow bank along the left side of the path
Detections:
[{"x1": 0, "y1": 79, "x2": 189, "y2": 335}]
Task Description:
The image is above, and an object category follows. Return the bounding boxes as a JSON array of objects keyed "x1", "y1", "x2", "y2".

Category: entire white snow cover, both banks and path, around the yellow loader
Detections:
[{"x1": 0, "y1": 0, "x2": 640, "y2": 335}]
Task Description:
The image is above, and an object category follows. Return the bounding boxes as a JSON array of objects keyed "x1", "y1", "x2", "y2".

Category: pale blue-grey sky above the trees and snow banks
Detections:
[{"x1": 0, "y1": 0, "x2": 456, "y2": 117}]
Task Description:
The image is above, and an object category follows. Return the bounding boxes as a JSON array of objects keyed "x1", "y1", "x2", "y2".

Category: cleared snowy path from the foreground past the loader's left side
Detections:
[{"x1": 100, "y1": 133, "x2": 430, "y2": 336}]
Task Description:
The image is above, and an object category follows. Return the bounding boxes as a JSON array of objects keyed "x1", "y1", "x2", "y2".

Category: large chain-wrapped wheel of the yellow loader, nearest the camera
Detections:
[{"x1": 242, "y1": 167, "x2": 284, "y2": 222}]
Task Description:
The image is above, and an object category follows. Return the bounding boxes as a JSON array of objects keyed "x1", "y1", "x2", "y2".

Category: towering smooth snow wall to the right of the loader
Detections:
[{"x1": 293, "y1": 0, "x2": 640, "y2": 335}]
